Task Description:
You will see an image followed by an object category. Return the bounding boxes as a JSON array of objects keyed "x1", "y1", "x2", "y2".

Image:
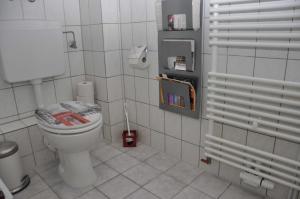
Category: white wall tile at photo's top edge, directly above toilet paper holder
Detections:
[{"x1": 131, "y1": 0, "x2": 147, "y2": 22}]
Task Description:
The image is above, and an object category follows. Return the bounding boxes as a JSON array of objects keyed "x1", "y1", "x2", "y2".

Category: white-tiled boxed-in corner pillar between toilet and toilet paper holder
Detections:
[{"x1": 80, "y1": 0, "x2": 124, "y2": 141}]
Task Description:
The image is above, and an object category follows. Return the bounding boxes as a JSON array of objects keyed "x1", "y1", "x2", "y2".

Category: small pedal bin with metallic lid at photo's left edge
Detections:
[{"x1": 0, "y1": 141, "x2": 30, "y2": 194}]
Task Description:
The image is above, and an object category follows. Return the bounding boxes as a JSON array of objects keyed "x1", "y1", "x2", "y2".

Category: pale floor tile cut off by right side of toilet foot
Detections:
[{"x1": 95, "y1": 164, "x2": 118, "y2": 186}]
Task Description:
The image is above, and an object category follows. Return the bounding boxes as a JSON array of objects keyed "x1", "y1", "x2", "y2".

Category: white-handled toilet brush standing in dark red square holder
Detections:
[{"x1": 123, "y1": 102, "x2": 137, "y2": 147}]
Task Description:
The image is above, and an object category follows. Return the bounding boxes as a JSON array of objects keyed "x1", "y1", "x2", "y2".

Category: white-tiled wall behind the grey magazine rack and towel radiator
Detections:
[{"x1": 110, "y1": 0, "x2": 300, "y2": 199}]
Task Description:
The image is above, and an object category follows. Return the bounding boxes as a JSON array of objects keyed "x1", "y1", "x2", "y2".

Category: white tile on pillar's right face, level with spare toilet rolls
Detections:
[{"x1": 107, "y1": 76, "x2": 123, "y2": 102}]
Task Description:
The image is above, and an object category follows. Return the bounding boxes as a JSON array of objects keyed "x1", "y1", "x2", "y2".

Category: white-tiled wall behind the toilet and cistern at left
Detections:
[{"x1": 0, "y1": 0, "x2": 85, "y2": 171}]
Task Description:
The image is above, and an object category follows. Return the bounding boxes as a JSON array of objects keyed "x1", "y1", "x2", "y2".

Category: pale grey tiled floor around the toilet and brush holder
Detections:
[{"x1": 15, "y1": 143, "x2": 262, "y2": 199}]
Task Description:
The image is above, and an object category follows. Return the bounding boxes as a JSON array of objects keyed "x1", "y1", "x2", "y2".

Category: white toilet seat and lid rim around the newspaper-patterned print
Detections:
[{"x1": 38, "y1": 101, "x2": 103, "y2": 135}]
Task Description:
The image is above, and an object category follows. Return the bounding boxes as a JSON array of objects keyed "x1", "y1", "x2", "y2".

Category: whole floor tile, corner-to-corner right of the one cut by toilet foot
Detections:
[{"x1": 123, "y1": 163, "x2": 160, "y2": 185}]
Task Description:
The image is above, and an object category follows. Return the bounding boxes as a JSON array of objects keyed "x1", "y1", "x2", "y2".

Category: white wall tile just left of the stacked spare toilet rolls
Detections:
[{"x1": 54, "y1": 78, "x2": 73, "y2": 102}]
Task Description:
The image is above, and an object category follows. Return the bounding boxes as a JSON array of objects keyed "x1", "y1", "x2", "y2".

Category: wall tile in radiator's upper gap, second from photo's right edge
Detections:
[{"x1": 254, "y1": 58, "x2": 286, "y2": 80}]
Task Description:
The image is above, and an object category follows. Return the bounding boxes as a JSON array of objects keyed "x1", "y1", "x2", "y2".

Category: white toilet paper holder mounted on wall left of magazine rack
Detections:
[{"x1": 128, "y1": 45, "x2": 150, "y2": 70}]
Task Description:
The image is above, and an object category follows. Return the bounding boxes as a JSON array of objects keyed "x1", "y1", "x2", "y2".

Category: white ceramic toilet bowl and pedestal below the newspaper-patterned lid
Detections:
[{"x1": 39, "y1": 102, "x2": 102, "y2": 188}]
